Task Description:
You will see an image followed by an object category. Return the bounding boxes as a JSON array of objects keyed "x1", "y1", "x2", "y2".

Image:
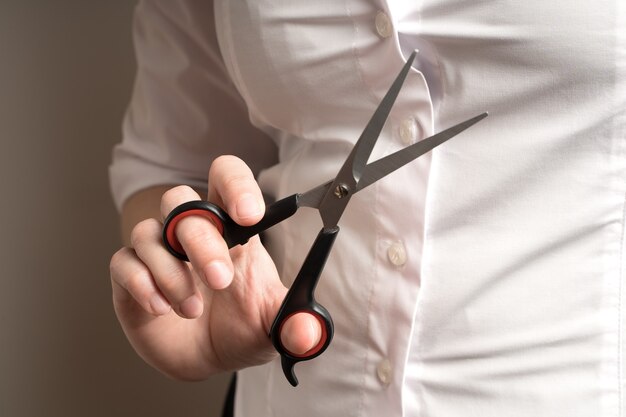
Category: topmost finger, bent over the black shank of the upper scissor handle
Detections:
[{"x1": 209, "y1": 155, "x2": 265, "y2": 226}]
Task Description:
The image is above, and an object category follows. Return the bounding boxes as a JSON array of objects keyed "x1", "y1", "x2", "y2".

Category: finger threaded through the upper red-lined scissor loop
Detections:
[{"x1": 161, "y1": 186, "x2": 233, "y2": 290}]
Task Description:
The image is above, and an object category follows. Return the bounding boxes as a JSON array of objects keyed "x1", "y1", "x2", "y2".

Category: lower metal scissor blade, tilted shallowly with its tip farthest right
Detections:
[{"x1": 357, "y1": 112, "x2": 488, "y2": 191}]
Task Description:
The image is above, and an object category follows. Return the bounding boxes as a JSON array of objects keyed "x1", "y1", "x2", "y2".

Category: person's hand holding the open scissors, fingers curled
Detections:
[{"x1": 110, "y1": 156, "x2": 321, "y2": 380}]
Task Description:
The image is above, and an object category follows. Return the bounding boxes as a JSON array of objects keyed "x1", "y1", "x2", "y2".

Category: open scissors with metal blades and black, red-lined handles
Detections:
[{"x1": 163, "y1": 52, "x2": 487, "y2": 387}]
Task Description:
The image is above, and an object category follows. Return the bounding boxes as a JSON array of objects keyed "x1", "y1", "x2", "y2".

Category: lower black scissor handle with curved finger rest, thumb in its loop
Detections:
[{"x1": 270, "y1": 227, "x2": 339, "y2": 387}]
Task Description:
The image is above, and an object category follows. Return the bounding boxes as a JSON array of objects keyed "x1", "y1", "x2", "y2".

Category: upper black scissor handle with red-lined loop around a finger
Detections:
[{"x1": 163, "y1": 194, "x2": 299, "y2": 261}]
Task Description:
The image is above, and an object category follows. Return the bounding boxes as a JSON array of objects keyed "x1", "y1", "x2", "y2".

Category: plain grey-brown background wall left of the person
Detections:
[{"x1": 0, "y1": 0, "x2": 225, "y2": 417}]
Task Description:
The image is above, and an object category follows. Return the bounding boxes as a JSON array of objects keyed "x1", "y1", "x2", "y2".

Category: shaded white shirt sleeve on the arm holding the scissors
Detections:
[{"x1": 109, "y1": 0, "x2": 276, "y2": 209}]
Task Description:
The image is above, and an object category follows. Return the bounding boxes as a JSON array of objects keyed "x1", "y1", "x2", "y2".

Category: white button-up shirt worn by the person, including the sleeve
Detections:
[{"x1": 111, "y1": 0, "x2": 626, "y2": 417}]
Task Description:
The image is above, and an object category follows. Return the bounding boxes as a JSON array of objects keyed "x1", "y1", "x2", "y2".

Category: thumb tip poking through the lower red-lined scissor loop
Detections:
[{"x1": 280, "y1": 313, "x2": 322, "y2": 355}]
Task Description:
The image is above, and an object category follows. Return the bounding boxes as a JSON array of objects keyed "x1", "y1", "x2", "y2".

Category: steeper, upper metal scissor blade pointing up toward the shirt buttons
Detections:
[{"x1": 338, "y1": 51, "x2": 416, "y2": 182}]
